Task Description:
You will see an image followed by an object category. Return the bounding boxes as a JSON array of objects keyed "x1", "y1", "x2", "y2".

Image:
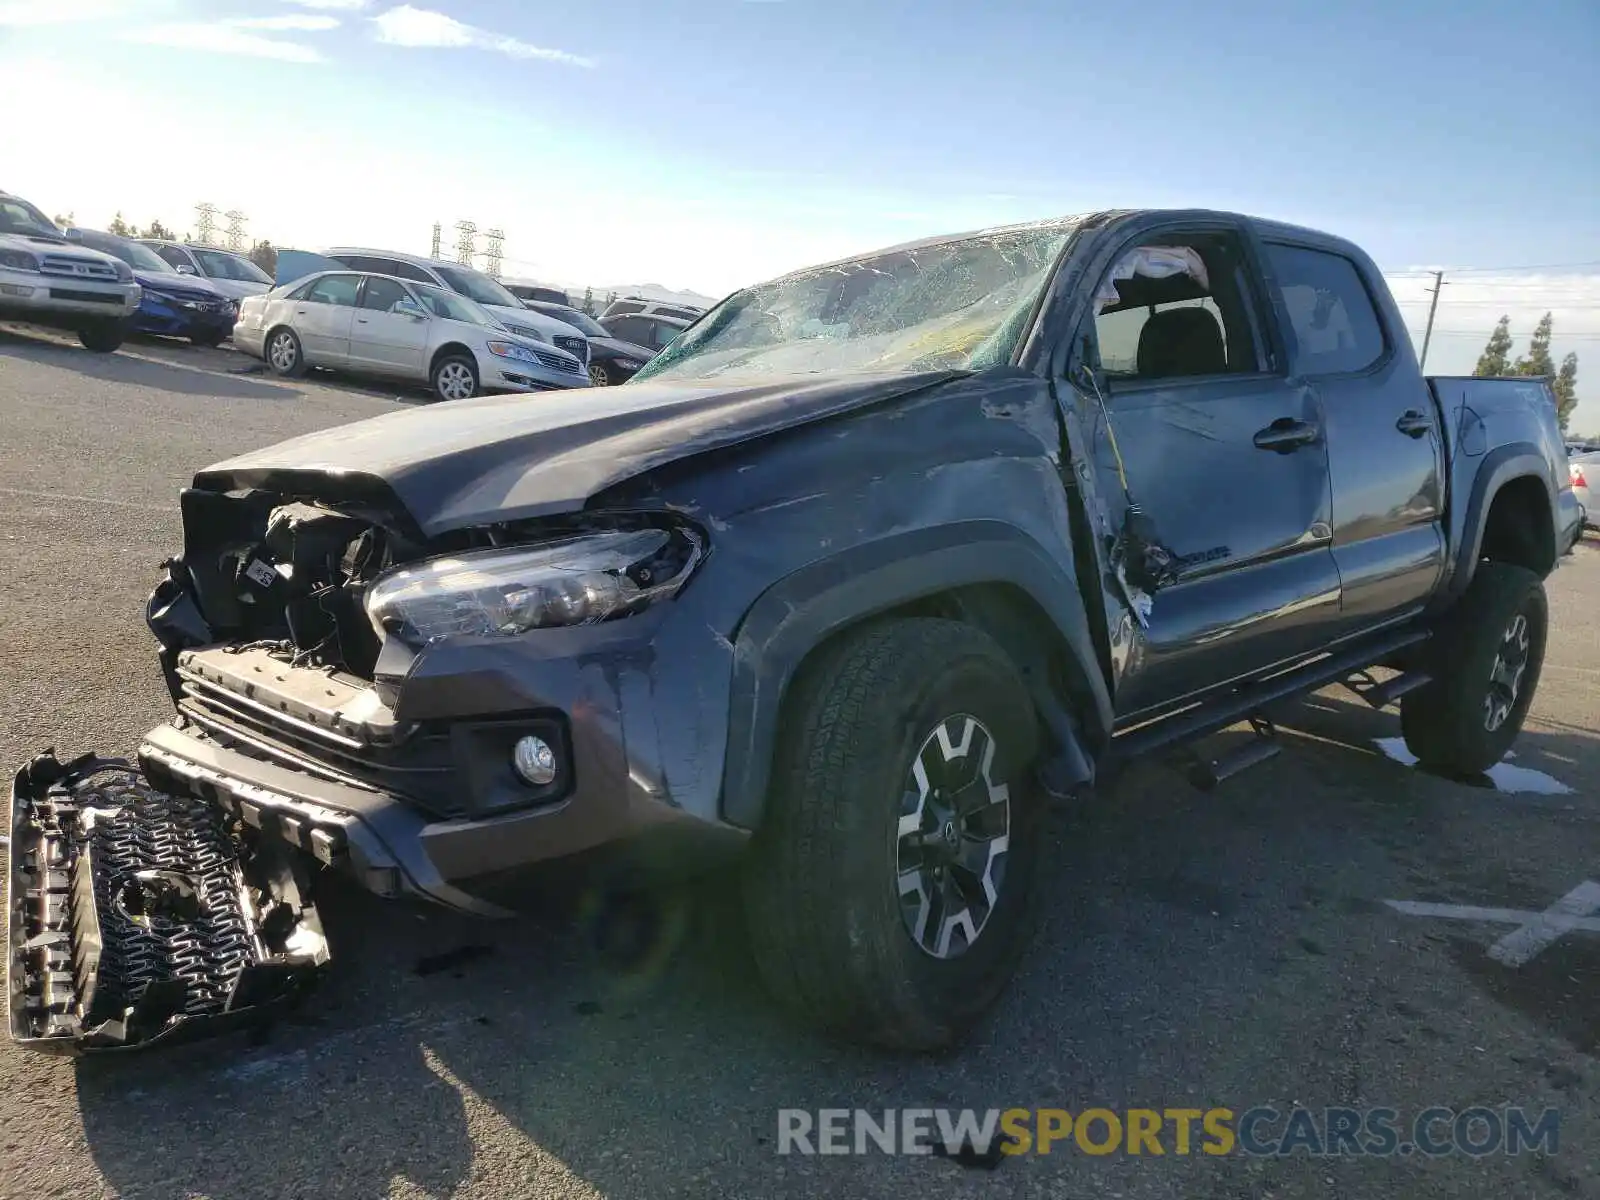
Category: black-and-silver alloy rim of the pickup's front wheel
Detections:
[{"x1": 894, "y1": 714, "x2": 1011, "y2": 958}]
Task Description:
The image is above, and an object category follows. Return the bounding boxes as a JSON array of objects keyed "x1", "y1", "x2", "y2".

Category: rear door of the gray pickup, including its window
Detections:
[{"x1": 1266, "y1": 242, "x2": 1445, "y2": 634}]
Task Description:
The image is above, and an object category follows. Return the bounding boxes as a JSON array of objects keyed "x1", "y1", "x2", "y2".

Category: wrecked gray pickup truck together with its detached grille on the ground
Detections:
[{"x1": 8, "y1": 211, "x2": 1578, "y2": 1053}]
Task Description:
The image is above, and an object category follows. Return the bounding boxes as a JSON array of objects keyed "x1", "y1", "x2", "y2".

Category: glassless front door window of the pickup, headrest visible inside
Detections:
[{"x1": 1094, "y1": 234, "x2": 1264, "y2": 386}]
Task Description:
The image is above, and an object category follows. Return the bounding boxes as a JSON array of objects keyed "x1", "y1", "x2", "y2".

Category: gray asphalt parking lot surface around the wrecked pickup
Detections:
[{"x1": 0, "y1": 326, "x2": 1600, "y2": 1200}]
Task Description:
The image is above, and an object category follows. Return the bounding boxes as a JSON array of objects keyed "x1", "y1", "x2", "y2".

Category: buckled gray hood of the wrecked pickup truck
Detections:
[{"x1": 195, "y1": 371, "x2": 957, "y2": 538}]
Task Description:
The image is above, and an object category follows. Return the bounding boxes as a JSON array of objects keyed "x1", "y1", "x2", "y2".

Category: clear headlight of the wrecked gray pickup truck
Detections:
[{"x1": 366, "y1": 530, "x2": 701, "y2": 643}]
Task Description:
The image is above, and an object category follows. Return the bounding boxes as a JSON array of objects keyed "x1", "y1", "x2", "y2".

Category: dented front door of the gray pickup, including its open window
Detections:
[{"x1": 1078, "y1": 226, "x2": 1339, "y2": 722}]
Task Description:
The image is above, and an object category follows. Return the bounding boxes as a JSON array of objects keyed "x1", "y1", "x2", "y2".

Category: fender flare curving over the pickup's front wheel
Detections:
[{"x1": 722, "y1": 522, "x2": 1112, "y2": 829}]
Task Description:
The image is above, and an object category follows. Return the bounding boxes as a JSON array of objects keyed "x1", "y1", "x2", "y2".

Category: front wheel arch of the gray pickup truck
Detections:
[{"x1": 722, "y1": 522, "x2": 1112, "y2": 829}]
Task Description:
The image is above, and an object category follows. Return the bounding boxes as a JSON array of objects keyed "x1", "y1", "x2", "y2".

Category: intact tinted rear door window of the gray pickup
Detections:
[{"x1": 1267, "y1": 245, "x2": 1384, "y2": 374}]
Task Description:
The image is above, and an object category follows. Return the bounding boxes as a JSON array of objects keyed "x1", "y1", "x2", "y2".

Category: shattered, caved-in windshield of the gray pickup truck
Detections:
[{"x1": 634, "y1": 221, "x2": 1077, "y2": 379}]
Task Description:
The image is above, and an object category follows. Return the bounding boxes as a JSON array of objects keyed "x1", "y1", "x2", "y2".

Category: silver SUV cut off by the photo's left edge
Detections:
[{"x1": 0, "y1": 192, "x2": 141, "y2": 354}]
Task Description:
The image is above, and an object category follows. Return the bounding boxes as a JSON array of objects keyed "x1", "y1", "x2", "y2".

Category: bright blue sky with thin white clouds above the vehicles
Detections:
[{"x1": 0, "y1": 0, "x2": 1600, "y2": 435}]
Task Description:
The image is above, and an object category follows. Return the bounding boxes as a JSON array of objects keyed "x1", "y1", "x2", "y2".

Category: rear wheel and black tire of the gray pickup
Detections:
[{"x1": 1400, "y1": 562, "x2": 1549, "y2": 776}]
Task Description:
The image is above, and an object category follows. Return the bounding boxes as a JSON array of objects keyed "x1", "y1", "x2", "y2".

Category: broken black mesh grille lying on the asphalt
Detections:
[{"x1": 8, "y1": 752, "x2": 328, "y2": 1054}]
